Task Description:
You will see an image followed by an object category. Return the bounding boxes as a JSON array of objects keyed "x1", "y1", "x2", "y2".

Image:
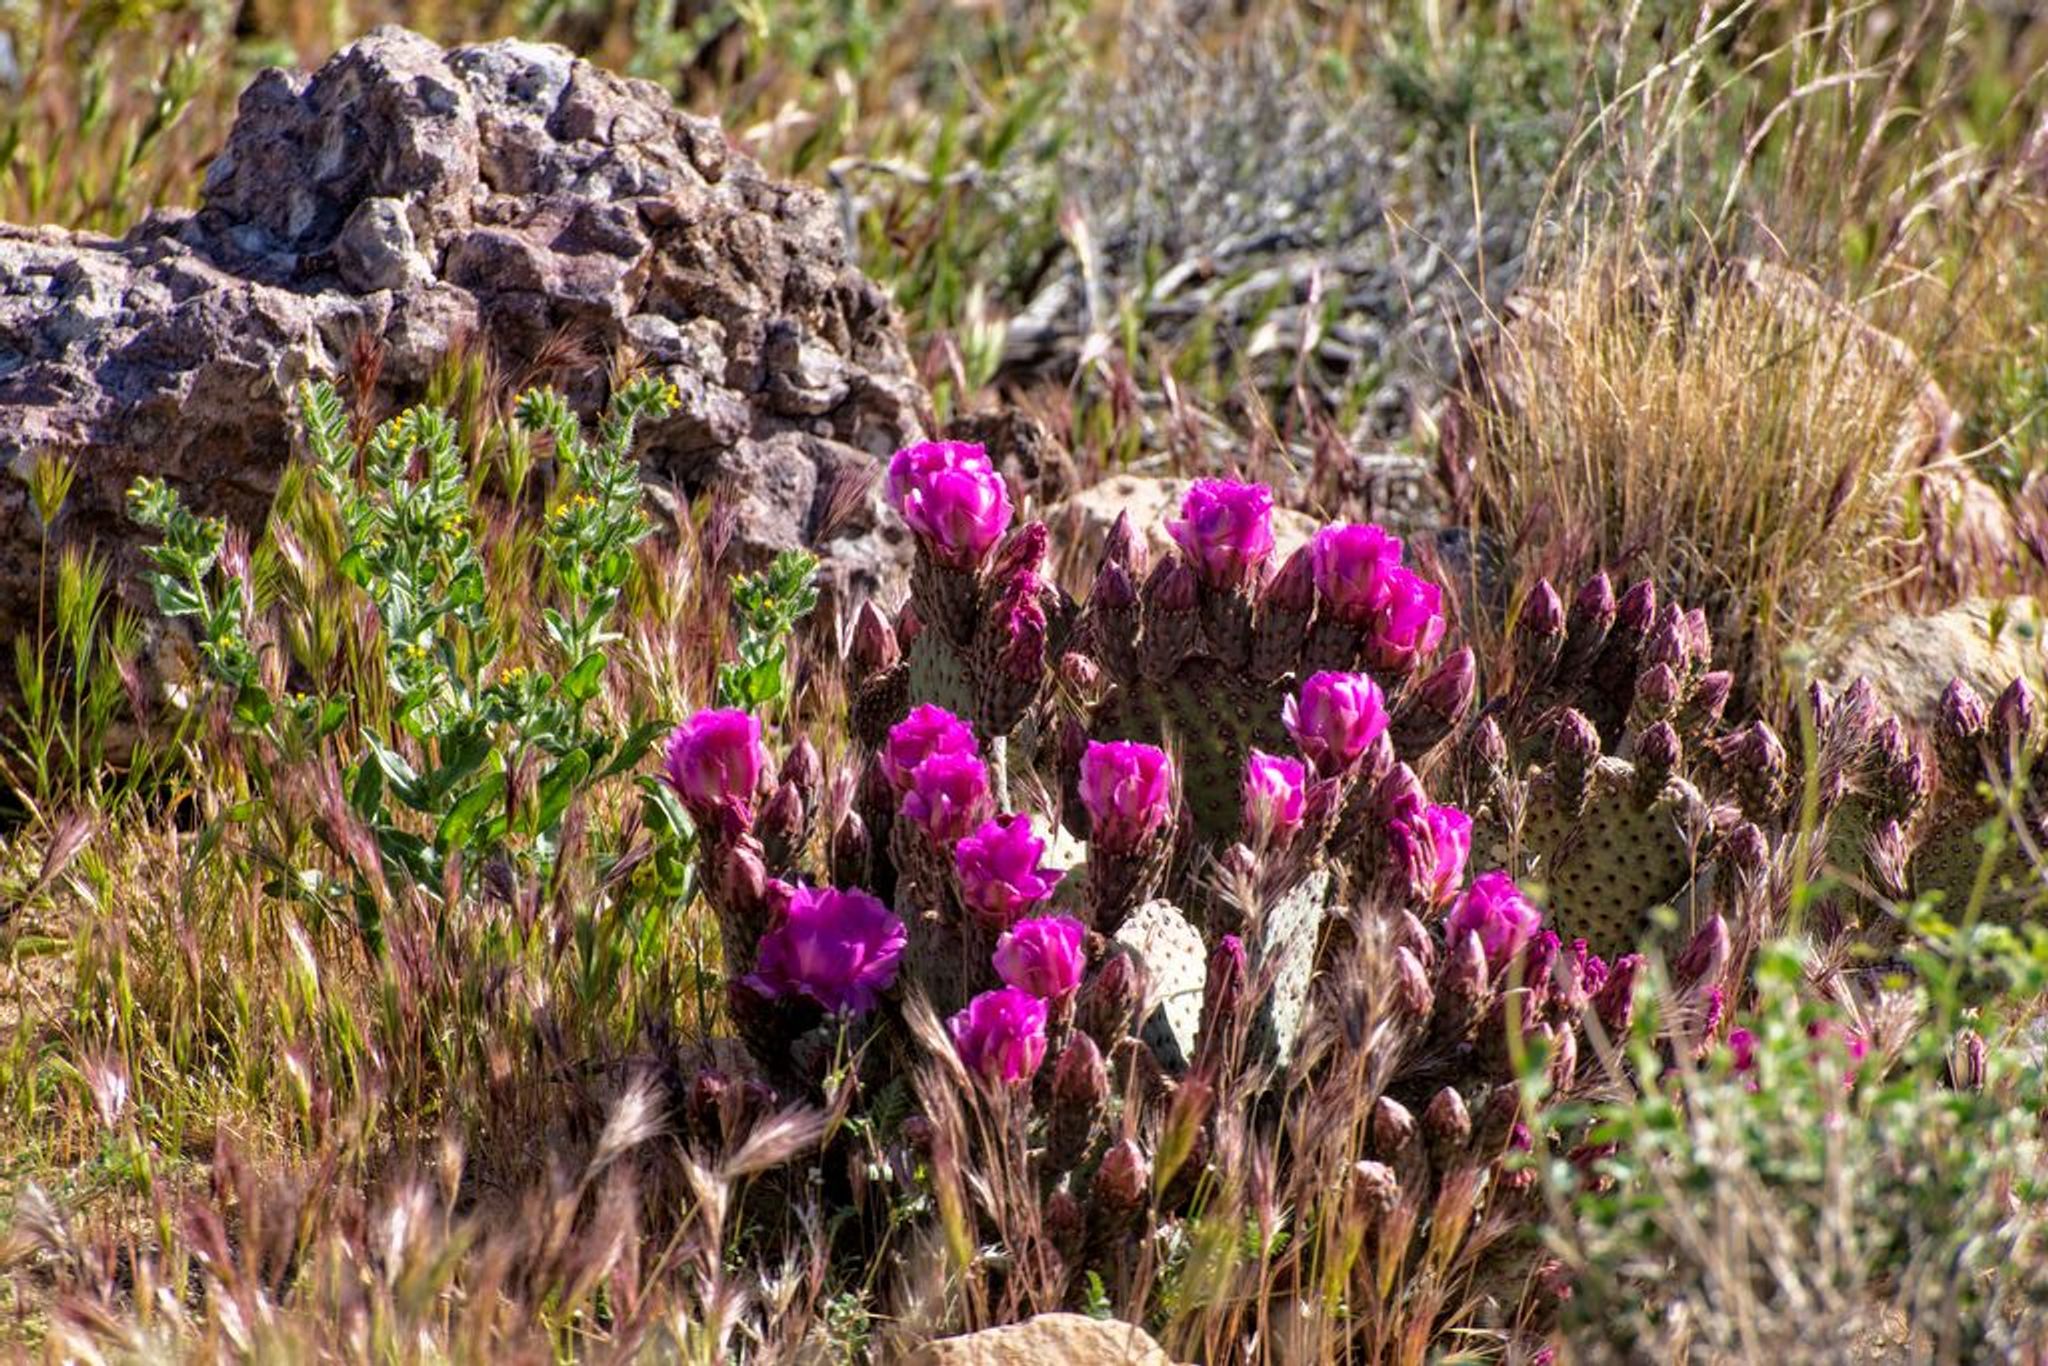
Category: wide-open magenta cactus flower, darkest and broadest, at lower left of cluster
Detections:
[{"x1": 745, "y1": 887, "x2": 905, "y2": 1016}]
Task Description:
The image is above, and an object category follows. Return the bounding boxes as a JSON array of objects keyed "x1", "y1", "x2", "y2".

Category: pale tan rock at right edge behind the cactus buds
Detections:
[{"x1": 1831, "y1": 598, "x2": 2048, "y2": 721}]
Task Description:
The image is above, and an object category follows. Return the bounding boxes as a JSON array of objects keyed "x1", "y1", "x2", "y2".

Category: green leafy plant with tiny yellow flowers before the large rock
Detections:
[{"x1": 131, "y1": 379, "x2": 676, "y2": 940}]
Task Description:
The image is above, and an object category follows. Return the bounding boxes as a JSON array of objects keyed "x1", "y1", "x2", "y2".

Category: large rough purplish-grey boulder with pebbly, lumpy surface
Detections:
[{"x1": 0, "y1": 29, "x2": 926, "y2": 635}]
